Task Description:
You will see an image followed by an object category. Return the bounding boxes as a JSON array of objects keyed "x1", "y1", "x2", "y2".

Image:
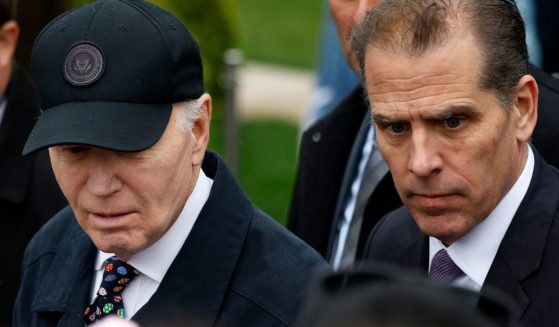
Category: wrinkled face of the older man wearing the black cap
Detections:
[{"x1": 49, "y1": 104, "x2": 207, "y2": 260}]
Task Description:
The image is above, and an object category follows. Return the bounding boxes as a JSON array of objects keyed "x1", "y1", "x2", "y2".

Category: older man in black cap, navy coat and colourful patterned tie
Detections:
[{"x1": 14, "y1": 0, "x2": 323, "y2": 326}]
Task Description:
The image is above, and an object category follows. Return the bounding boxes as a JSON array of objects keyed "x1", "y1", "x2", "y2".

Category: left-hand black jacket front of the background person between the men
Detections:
[{"x1": 287, "y1": 87, "x2": 368, "y2": 257}]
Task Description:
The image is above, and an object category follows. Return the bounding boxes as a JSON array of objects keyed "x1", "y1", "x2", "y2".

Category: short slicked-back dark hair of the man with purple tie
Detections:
[{"x1": 351, "y1": 0, "x2": 528, "y2": 107}]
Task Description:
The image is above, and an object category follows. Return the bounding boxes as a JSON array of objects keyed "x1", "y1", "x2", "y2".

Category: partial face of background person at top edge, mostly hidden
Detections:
[{"x1": 330, "y1": 0, "x2": 381, "y2": 69}]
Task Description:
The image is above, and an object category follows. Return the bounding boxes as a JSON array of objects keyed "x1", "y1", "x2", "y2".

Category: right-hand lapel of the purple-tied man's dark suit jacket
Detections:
[{"x1": 482, "y1": 150, "x2": 559, "y2": 317}]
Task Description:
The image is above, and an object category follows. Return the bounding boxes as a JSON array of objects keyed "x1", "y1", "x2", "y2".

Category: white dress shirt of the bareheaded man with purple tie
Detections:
[{"x1": 429, "y1": 146, "x2": 534, "y2": 291}]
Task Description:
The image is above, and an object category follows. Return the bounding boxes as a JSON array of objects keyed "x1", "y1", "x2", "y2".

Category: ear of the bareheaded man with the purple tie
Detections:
[{"x1": 514, "y1": 75, "x2": 539, "y2": 142}]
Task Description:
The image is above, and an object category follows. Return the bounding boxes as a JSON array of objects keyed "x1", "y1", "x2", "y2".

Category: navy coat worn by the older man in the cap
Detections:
[{"x1": 14, "y1": 153, "x2": 325, "y2": 327}]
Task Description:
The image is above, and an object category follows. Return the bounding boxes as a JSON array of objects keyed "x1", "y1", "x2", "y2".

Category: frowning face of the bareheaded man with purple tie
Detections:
[{"x1": 365, "y1": 36, "x2": 537, "y2": 245}]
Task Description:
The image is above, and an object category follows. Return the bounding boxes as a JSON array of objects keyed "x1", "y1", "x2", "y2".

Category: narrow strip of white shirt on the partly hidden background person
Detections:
[{"x1": 332, "y1": 124, "x2": 375, "y2": 270}]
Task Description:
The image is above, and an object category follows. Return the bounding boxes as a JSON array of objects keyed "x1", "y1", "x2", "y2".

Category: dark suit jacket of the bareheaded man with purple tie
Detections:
[{"x1": 365, "y1": 151, "x2": 559, "y2": 326}]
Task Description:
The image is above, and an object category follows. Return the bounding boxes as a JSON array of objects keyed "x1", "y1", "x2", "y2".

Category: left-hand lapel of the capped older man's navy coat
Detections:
[{"x1": 31, "y1": 217, "x2": 97, "y2": 326}]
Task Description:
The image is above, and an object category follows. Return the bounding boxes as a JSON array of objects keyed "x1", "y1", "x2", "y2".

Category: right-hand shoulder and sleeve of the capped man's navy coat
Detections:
[{"x1": 231, "y1": 208, "x2": 327, "y2": 325}]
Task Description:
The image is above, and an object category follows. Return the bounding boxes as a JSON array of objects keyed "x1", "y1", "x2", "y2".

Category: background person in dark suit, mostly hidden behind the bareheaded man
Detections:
[{"x1": 288, "y1": 0, "x2": 402, "y2": 269}]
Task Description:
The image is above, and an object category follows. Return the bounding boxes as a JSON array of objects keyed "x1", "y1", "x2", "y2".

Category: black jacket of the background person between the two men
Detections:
[{"x1": 288, "y1": 87, "x2": 402, "y2": 258}]
